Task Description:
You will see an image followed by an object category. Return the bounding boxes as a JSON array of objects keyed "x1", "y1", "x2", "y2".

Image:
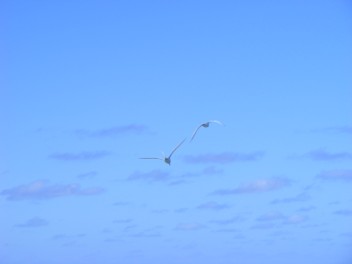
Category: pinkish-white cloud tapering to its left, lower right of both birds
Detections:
[{"x1": 212, "y1": 178, "x2": 290, "y2": 195}]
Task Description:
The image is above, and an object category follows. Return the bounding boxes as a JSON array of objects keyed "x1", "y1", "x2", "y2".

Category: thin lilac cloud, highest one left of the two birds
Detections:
[{"x1": 75, "y1": 124, "x2": 149, "y2": 137}]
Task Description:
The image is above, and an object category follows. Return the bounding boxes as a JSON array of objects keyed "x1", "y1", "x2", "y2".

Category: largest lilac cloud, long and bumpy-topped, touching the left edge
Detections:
[{"x1": 0, "y1": 180, "x2": 104, "y2": 201}]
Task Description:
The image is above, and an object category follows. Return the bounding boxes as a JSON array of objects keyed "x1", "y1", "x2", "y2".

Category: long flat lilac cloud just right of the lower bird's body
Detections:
[{"x1": 184, "y1": 151, "x2": 264, "y2": 164}]
